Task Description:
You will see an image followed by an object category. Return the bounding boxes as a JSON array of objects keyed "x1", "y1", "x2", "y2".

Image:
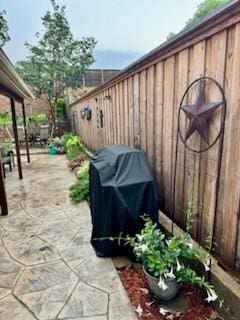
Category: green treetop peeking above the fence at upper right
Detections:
[{"x1": 185, "y1": 0, "x2": 229, "y2": 28}]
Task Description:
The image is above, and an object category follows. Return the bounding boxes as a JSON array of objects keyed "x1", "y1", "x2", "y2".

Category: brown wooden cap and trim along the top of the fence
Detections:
[{"x1": 70, "y1": 0, "x2": 240, "y2": 107}]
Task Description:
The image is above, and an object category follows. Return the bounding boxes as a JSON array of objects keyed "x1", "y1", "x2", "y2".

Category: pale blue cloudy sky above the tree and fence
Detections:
[{"x1": 0, "y1": 0, "x2": 201, "y2": 69}]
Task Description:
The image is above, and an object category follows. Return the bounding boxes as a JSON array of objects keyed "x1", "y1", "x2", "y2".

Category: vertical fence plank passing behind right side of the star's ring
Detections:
[{"x1": 201, "y1": 31, "x2": 227, "y2": 242}]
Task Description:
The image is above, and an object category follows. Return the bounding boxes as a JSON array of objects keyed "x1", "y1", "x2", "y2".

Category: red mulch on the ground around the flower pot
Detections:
[{"x1": 119, "y1": 267, "x2": 216, "y2": 320}]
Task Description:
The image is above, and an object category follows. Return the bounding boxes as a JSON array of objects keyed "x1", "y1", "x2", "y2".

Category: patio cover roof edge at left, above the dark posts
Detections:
[{"x1": 0, "y1": 49, "x2": 34, "y2": 100}]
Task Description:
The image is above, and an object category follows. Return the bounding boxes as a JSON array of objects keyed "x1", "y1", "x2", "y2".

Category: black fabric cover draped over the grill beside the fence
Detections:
[{"x1": 90, "y1": 145, "x2": 157, "y2": 257}]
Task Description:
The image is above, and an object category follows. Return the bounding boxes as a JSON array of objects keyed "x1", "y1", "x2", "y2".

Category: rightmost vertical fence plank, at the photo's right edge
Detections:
[{"x1": 220, "y1": 24, "x2": 240, "y2": 265}]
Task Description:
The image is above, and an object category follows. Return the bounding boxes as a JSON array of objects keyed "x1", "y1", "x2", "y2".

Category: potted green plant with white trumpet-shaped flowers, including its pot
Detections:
[{"x1": 125, "y1": 212, "x2": 218, "y2": 302}]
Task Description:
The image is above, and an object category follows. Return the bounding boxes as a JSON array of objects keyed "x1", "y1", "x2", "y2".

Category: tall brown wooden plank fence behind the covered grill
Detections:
[{"x1": 71, "y1": 1, "x2": 240, "y2": 266}]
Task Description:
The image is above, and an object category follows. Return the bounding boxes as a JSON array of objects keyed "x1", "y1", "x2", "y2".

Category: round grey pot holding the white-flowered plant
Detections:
[{"x1": 143, "y1": 269, "x2": 179, "y2": 301}]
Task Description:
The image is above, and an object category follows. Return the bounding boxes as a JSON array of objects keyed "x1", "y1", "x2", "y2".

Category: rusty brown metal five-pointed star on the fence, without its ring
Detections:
[{"x1": 181, "y1": 80, "x2": 223, "y2": 145}]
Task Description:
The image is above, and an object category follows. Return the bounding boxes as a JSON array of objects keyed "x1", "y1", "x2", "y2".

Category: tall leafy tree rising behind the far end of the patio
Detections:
[{"x1": 16, "y1": 0, "x2": 96, "y2": 124}]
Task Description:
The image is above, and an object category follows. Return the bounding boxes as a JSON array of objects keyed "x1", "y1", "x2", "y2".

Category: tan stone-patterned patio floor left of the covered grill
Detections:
[{"x1": 0, "y1": 154, "x2": 136, "y2": 320}]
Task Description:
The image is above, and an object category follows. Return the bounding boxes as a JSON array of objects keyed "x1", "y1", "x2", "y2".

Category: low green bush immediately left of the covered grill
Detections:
[{"x1": 69, "y1": 160, "x2": 89, "y2": 203}]
